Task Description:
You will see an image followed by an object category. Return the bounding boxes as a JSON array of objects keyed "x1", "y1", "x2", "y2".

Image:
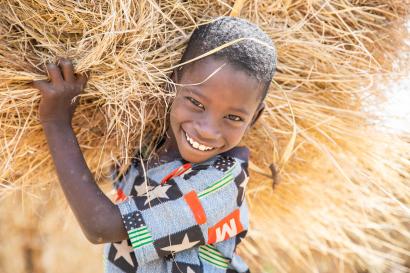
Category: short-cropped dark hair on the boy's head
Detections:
[{"x1": 179, "y1": 16, "x2": 276, "y2": 100}]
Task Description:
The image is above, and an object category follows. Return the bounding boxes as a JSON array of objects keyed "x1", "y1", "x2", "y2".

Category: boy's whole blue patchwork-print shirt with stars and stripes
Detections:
[{"x1": 104, "y1": 147, "x2": 249, "y2": 273}]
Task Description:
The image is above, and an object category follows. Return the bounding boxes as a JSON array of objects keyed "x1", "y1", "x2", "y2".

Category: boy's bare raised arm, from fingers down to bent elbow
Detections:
[{"x1": 33, "y1": 59, "x2": 127, "y2": 243}]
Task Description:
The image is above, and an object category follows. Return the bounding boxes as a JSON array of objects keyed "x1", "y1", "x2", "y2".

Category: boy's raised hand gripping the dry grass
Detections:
[{"x1": 33, "y1": 59, "x2": 88, "y2": 125}]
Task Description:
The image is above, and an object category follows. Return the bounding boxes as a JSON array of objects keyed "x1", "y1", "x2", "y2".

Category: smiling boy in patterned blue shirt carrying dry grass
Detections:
[{"x1": 34, "y1": 17, "x2": 276, "y2": 272}]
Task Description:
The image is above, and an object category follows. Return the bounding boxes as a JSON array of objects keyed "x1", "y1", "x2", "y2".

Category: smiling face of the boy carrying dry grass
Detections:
[{"x1": 170, "y1": 57, "x2": 263, "y2": 163}]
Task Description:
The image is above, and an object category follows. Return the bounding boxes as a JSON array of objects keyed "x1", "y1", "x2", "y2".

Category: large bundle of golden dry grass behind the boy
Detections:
[{"x1": 0, "y1": 0, "x2": 410, "y2": 272}]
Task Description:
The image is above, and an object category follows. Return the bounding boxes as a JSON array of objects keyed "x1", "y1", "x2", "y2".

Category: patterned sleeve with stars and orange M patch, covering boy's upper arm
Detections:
[{"x1": 117, "y1": 156, "x2": 248, "y2": 265}]
